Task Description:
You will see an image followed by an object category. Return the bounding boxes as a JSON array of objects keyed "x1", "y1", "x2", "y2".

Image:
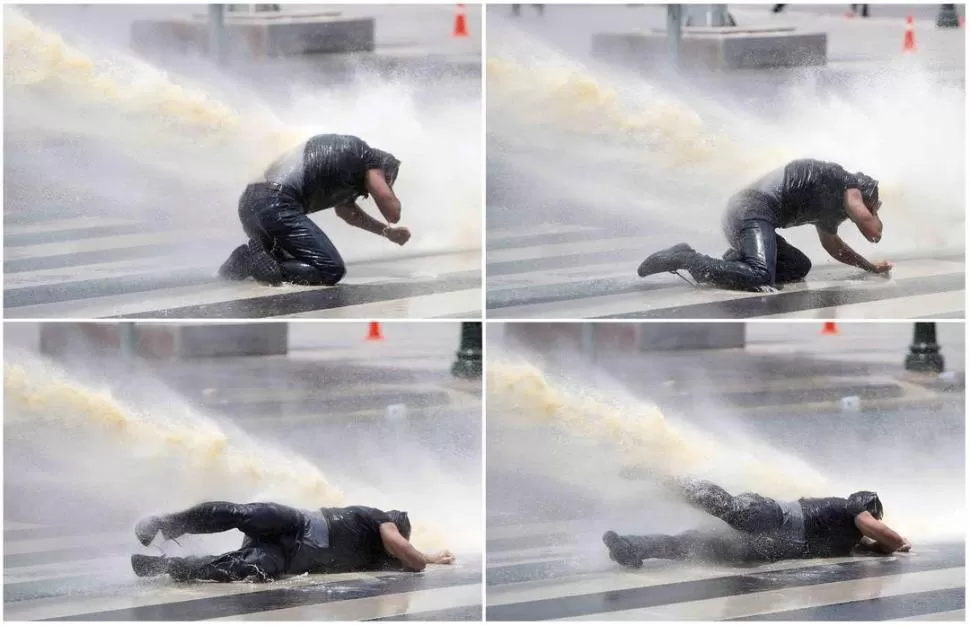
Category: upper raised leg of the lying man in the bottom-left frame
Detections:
[{"x1": 135, "y1": 502, "x2": 305, "y2": 546}]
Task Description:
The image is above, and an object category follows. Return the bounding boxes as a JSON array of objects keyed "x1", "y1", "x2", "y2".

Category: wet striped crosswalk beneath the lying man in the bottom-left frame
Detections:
[{"x1": 4, "y1": 521, "x2": 482, "y2": 621}]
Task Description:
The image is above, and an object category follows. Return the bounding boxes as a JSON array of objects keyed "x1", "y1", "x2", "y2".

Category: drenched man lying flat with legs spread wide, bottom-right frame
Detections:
[{"x1": 603, "y1": 481, "x2": 910, "y2": 568}]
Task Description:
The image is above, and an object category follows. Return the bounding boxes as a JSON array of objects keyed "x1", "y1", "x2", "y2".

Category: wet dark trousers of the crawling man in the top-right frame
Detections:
[{"x1": 688, "y1": 219, "x2": 812, "y2": 291}]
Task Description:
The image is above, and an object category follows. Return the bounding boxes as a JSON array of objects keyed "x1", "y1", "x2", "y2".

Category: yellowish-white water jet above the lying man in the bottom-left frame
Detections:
[{"x1": 4, "y1": 356, "x2": 458, "y2": 553}]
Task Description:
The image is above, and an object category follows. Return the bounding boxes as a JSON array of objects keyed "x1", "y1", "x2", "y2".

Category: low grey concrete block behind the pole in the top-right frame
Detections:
[{"x1": 593, "y1": 28, "x2": 828, "y2": 71}]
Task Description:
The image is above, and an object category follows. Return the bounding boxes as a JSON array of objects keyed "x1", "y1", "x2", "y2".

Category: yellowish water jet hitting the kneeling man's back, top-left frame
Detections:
[{"x1": 4, "y1": 9, "x2": 303, "y2": 182}]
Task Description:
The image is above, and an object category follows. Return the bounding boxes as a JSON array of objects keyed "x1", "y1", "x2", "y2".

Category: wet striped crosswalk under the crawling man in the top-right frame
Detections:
[{"x1": 486, "y1": 224, "x2": 966, "y2": 319}]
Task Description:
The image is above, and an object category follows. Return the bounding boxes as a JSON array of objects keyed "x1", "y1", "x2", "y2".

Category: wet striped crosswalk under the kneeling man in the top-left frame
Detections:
[{"x1": 4, "y1": 218, "x2": 482, "y2": 319}]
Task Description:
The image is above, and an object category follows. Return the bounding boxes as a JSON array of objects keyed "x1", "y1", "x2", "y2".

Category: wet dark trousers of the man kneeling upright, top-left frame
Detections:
[{"x1": 239, "y1": 183, "x2": 347, "y2": 285}]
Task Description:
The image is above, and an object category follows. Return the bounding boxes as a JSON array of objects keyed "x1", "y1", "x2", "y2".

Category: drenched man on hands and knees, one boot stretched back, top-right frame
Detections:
[{"x1": 637, "y1": 159, "x2": 893, "y2": 291}]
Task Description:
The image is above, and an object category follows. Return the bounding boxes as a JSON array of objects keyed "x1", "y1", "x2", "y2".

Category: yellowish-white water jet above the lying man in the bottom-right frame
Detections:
[{"x1": 486, "y1": 355, "x2": 965, "y2": 542}]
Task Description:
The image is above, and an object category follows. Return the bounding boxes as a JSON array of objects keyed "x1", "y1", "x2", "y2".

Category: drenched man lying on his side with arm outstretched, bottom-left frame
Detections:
[{"x1": 131, "y1": 502, "x2": 454, "y2": 582}]
